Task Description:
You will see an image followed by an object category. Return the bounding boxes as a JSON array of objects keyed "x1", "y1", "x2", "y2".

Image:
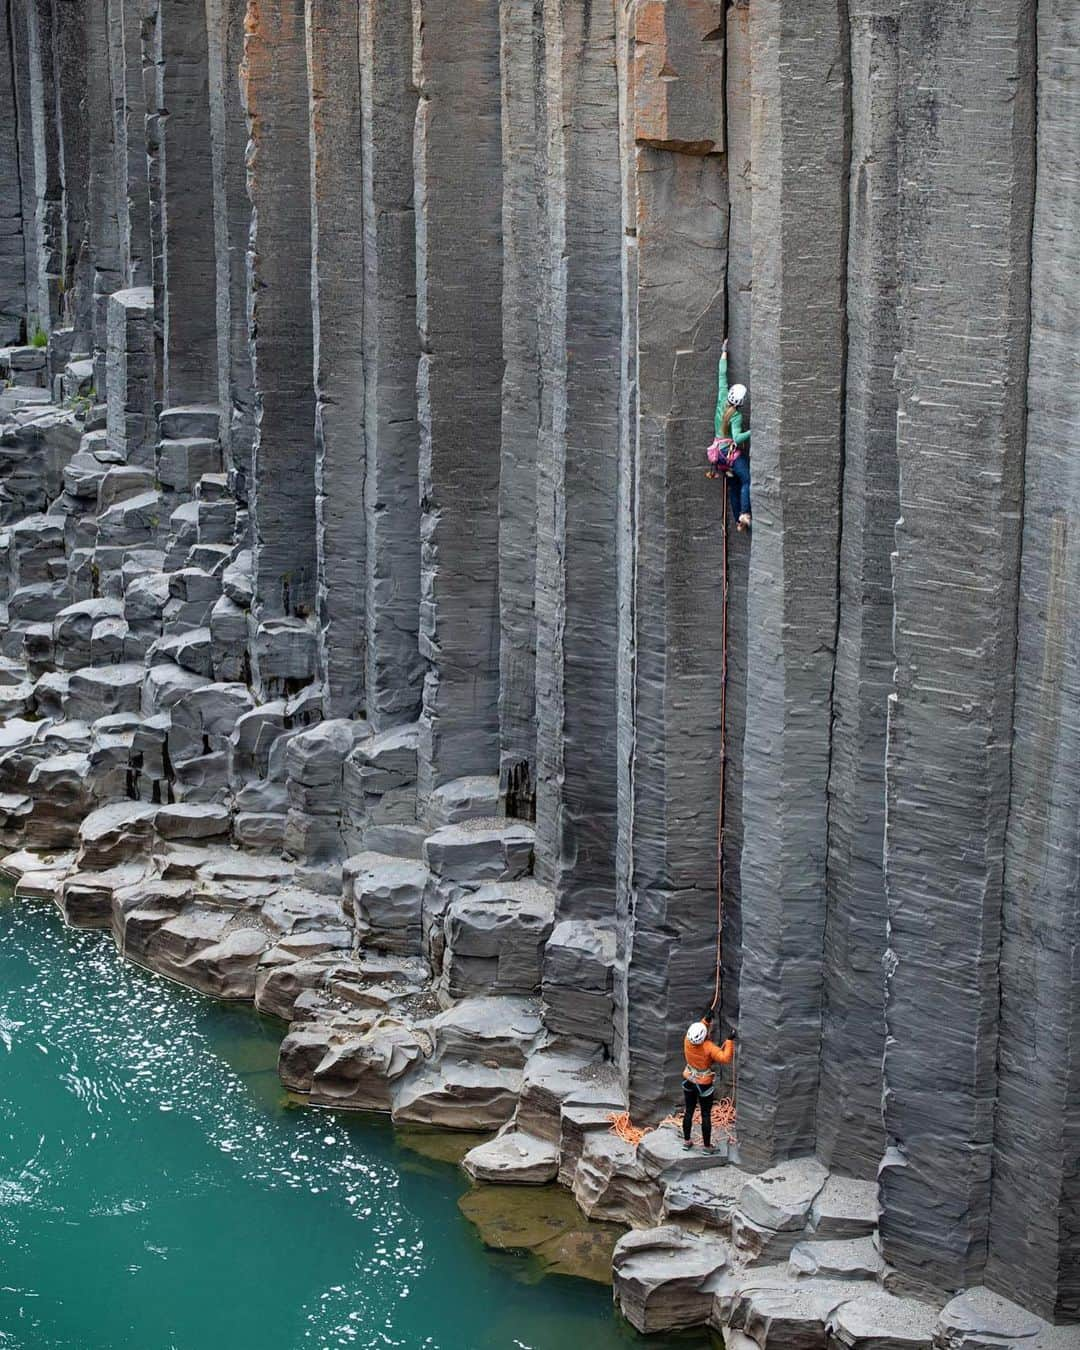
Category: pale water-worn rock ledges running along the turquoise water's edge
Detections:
[{"x1": 0, "y1": 837, "x2": 1076, "y2": 1350}]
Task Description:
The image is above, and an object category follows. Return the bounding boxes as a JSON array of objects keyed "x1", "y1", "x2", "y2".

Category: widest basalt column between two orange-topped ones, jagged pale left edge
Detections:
[{"x1": 413, "y1": 0, "x2": 502, "y2": 799}]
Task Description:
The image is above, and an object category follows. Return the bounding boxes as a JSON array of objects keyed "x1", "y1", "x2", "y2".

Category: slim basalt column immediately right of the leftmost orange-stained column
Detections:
[{"x1": 305, "y1": 0, "x2": 367, "y2": 717}]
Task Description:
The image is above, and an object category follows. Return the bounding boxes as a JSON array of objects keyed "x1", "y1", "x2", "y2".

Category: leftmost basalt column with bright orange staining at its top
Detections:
[{"x1": 243, "y1": 0, "x2": 316, "y2": 642}]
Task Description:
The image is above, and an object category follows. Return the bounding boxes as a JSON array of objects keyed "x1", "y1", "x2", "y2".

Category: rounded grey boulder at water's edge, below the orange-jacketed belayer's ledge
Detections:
[{"x1": 613, "y1": 1227, "x2": 728, "y2": 1335}]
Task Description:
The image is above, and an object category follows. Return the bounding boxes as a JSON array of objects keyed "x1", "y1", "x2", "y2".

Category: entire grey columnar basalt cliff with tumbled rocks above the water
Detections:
[{"x1": 0, "y1": 0, "x2": 1080, "y2": 1333}]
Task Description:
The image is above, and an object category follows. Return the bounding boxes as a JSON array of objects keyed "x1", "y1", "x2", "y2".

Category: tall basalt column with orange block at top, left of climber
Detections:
[{"x1": 617, "y1": 0, "x2": 728, "y2": 1121}]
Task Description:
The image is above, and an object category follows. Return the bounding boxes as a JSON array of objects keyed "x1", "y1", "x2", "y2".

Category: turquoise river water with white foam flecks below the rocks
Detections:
[{"x1": 0, "y1": 899, "x2": 705, "y2": 1350}]
